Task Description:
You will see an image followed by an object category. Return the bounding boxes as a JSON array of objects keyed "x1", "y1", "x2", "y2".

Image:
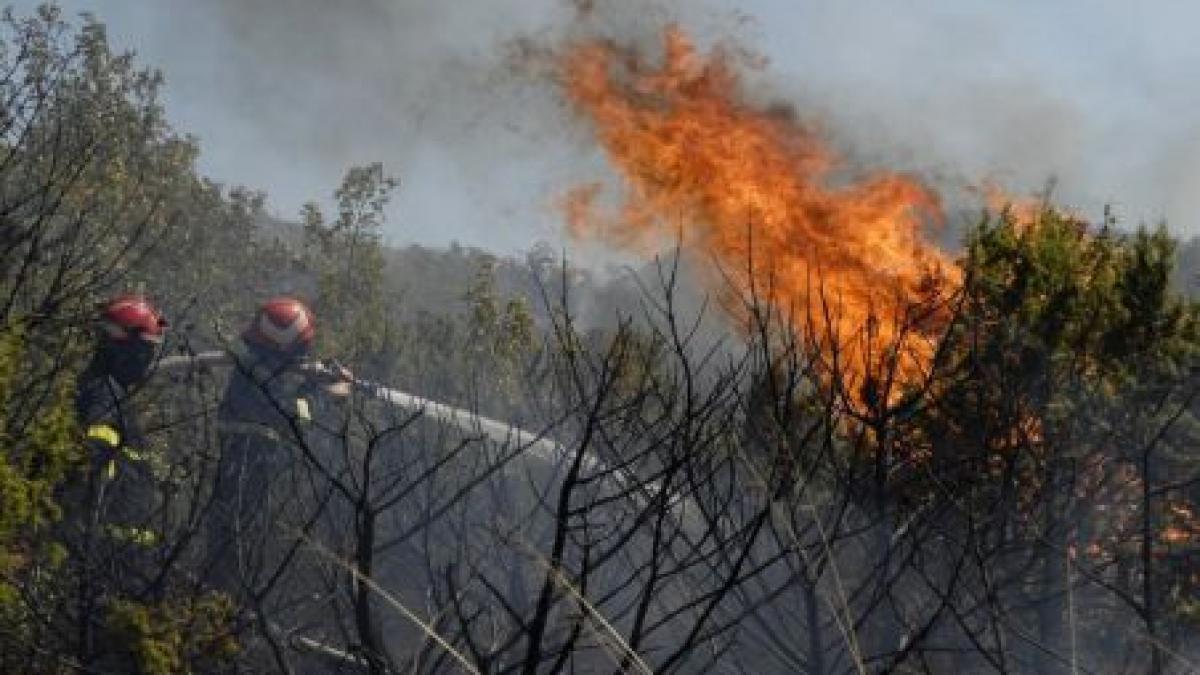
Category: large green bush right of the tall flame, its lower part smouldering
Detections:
[{"x1": 906, "y1": 207, "x2": 1200, "y2": 640}]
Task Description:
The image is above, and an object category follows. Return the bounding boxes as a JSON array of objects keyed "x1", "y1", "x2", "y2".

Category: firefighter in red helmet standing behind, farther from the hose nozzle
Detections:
[{"x1": 71, "y1": 294, "x2": 167, "y2": 663}]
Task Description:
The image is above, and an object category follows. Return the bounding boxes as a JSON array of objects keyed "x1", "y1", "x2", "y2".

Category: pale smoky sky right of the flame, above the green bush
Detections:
[{"x1": 715, "y1": 0, "x2": 1200, "y2": 235}]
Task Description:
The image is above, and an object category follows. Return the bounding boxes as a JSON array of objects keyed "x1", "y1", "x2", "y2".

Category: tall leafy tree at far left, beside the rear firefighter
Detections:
[{"x1": 0, "y1": 6, "x2": 243, "y2": 671}]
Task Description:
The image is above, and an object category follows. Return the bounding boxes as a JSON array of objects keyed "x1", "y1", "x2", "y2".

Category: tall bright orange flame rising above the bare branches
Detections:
[{"x1": 562, "y1": 28, "x2": 960, "y2": 398}]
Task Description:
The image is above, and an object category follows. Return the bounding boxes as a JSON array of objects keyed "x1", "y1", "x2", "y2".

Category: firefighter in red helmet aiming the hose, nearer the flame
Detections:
[{"x1": 208, "y1": 297, "x2": 352, "y2": 592}]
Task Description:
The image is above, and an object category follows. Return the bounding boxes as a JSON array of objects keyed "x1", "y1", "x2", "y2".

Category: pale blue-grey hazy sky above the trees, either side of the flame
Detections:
[{"x1": 16, "y1": 0, "x2": 1200, "y2": 252}]
